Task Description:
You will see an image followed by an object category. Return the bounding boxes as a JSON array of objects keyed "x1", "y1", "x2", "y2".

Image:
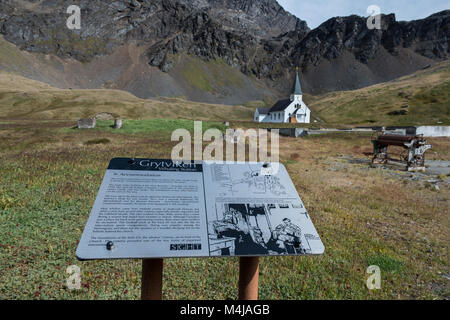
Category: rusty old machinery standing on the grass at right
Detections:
[{"x1": 372, "y1": 133, "x2": 431, "y2": 171}]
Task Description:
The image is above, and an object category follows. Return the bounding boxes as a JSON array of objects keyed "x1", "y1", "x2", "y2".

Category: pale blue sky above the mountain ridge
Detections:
[{"x1": 278, "y1": 0, "x2": 450, "y2": 29}]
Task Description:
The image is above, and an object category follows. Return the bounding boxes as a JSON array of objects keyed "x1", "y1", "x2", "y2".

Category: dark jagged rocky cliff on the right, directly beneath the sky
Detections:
[{"x1": 290, "y1": 11, "x2": 450, "y2": 66}]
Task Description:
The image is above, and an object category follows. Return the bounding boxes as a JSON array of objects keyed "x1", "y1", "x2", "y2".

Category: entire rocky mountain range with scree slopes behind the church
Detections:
[{"x1": 0, "y1": 0, "x2": 450, "y2": 103}]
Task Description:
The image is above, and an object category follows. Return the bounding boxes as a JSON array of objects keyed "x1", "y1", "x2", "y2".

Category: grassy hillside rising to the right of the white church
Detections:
[{"x1": 307, "y1": 61, "x2": 450, "y2": 125}]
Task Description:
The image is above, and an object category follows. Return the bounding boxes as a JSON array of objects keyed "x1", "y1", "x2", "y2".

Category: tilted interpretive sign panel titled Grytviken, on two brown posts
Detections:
[{"x1": 77, "y1": 158, "x2": 324, "y2": 260}]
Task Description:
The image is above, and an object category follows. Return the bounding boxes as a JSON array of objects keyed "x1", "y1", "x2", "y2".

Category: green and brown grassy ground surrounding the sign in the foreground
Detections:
[{"x1": 0, "y1": 120, "x2": 450, "y2": 299}]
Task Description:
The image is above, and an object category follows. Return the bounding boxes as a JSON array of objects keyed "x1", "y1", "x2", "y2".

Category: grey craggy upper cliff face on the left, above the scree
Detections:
[{"x1": 0, "y1": 0, "x2": 309, "y2": 61}]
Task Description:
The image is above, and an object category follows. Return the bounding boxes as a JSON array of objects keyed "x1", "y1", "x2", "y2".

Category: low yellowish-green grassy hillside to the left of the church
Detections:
[{"x1": 0, "y1": 72, "x2": 253, "y2": 121}]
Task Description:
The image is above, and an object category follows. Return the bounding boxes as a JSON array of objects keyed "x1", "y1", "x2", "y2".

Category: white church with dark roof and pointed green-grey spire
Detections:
[{"x1": 255, "y1": 68, "x2": 311, "y2": 123}]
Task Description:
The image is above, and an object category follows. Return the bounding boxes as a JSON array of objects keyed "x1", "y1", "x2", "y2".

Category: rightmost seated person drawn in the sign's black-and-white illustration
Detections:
[{"x1": 272, "y1": 218, "x2": 303, "y2": 254}]
